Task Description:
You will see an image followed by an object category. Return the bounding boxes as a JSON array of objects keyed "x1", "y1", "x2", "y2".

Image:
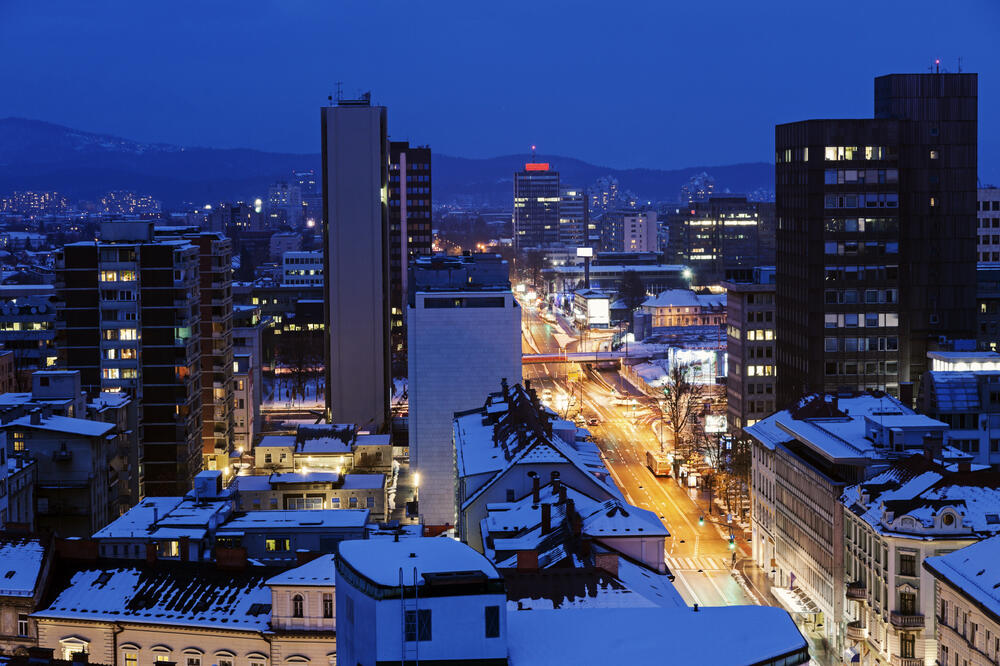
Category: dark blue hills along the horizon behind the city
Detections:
[{"x1": 0, "y1": 118, "x2": 774, "y2": 207}]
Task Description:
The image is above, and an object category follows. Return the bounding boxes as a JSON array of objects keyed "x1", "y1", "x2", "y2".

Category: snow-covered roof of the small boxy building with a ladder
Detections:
[{"x1": 340, "y1": 537, "x2": 500, "y2": 586}]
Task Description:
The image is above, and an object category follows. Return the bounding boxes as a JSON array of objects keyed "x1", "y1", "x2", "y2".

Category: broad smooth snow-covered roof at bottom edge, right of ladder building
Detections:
[{"x1": 507, "y1": 606, "x2": 808, "y2": 666}]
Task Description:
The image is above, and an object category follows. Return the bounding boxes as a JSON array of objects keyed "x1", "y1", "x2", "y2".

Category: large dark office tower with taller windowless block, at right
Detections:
[{"x1": 775, "y1": 74, "x2": 977, "y2": 407}]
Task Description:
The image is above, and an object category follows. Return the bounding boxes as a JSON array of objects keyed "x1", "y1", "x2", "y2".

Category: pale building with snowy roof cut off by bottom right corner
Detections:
[{"x1": 924, "y1": 537, "x2": 1000, "y2": 666}]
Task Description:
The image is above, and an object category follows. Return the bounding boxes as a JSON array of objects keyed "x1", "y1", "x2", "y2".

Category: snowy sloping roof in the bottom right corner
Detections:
[{"x1": 924, "y1": 536, "x2": 1000, "y2": 622}]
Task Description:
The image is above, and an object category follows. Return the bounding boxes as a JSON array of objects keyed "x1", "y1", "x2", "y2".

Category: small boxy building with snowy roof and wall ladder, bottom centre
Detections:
[{"x1": 336, "y1": 538, "x2": 508, "y2": 666}]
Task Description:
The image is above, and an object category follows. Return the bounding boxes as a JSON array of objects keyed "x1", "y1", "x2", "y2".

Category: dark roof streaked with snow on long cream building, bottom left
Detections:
[{"x1": 34, "y1": 563, "x2": 271, "y2": 632}]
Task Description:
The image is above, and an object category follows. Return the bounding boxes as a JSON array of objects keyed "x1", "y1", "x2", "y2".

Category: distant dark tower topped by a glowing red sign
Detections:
[{"x1": 514, "y1": 162, "x2": 559, "y2": 250}]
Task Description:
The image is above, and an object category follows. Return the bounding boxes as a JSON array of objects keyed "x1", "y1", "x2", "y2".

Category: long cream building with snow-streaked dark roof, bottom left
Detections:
[{"x1": 31, "y1": 559, "x2": 337, "y2": 666}]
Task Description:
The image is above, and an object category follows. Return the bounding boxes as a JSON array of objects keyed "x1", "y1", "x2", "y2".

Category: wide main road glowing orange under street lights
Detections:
[{"x1": 522, "y1": 300, "x2": 762, "y2": 606}]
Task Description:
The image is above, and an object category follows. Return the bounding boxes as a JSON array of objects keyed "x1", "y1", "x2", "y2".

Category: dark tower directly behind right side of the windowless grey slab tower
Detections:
[{"x1": 389, "y1": 141, "x2": 432, "y2": 353}]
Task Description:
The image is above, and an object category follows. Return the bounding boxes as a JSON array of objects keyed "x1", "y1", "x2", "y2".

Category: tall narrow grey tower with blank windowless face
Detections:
[{"x1": 320, "y1": 95, "x2": 390, "y2": 429}]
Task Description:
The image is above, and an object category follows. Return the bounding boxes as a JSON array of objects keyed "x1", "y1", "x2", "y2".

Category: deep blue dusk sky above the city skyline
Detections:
[{"x1": 0, "y1": 0, "x2": 1000, "y2": 181}]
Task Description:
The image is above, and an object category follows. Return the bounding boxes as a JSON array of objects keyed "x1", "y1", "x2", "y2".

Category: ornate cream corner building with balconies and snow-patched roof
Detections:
[{"x1": 842, "y1": 455, "x2": 1000, "y2": 666}]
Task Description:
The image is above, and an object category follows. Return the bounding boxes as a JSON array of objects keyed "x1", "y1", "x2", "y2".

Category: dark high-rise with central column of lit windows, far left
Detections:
[{"x1": 56, "y1": 222, "x2": 202, "y2": 496}]
